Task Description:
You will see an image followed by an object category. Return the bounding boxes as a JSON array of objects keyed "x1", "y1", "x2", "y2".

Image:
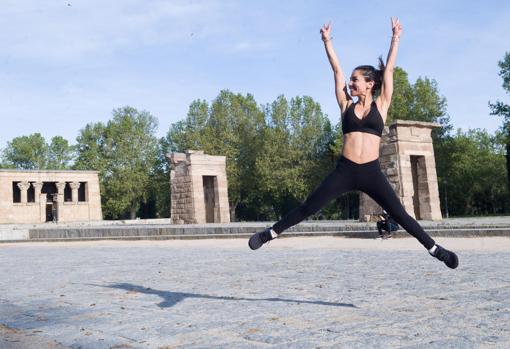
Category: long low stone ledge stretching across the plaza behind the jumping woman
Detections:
[{"x1": 0, "y1": 216, "x2": 510, "y2": 242}]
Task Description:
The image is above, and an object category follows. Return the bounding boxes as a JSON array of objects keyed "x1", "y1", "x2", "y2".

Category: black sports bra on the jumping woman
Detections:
[{"x1": 342, "y1": 101, "x2": 384, "y2": 137}]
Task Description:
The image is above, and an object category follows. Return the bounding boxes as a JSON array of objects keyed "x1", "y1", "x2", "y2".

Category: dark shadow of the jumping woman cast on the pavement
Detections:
[{"x1": 94, "y1": 283, "x2": 357, "y2": 308}]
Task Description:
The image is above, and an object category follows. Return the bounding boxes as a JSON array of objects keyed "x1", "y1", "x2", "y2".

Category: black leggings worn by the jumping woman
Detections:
[{"x1": 273, "y1": 156, "x2": 435, "y2": 250}]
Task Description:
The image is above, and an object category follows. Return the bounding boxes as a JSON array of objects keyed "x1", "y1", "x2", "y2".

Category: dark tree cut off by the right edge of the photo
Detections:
[{"x1": 489, "y1": 52, "x2": 510, "y2": 192}]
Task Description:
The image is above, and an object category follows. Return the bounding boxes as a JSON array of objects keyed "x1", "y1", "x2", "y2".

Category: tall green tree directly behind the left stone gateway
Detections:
[{"x1": 164, "y1": 90, "x2": 264, "y2": 220}]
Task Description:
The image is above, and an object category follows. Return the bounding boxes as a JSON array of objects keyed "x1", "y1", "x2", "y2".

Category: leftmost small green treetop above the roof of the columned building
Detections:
[{"x1": 2, "y1": 133, "x2": 48, "y2": 170}]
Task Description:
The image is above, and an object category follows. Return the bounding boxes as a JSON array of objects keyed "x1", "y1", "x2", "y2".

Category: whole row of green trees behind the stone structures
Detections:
[{"x1": 0, "y1": 59, "x2": 510, "y2": 220}]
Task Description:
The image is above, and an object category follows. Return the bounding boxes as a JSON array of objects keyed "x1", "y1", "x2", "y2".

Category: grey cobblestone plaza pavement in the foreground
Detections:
[{"x1": 0, "y1": 237, "x2": 510, "y2": 349}]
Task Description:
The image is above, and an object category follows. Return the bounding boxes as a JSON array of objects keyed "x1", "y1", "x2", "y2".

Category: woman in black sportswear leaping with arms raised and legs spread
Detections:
[{"x1": 248, "y1": 18, "x2": 459, "y2": 269}]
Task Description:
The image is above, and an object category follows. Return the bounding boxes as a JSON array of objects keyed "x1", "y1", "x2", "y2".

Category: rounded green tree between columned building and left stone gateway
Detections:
[{"x1": 75, "y1": 106, "x2": 158, "y2": 219}]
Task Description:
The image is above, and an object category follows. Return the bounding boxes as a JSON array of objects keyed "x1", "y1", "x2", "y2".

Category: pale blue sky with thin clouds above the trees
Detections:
[{"x1": 0, "y1": 0, "x2": 510, "y2": 148}]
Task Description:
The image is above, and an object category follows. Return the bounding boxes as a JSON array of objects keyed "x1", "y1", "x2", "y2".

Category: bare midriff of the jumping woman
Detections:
[{"x1": 342, "y1": 132, "x2": 381, "y2": 164}]
